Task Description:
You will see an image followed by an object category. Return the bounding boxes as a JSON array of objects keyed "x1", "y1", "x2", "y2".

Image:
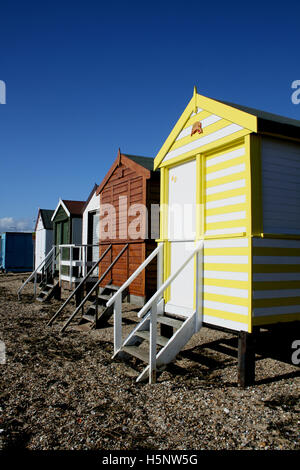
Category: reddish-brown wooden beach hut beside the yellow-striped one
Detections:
[{"x1": 97, "y1": 150, "x2": 160, "y2": 305}]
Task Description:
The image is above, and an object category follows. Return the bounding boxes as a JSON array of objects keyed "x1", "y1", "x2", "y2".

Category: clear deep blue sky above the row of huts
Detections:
[{"x1": 0, "y1": 0, "x2": 300, "y2": 230}]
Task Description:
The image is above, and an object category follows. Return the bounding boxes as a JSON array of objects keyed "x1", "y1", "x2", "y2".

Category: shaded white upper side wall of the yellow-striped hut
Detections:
[{"x1": 262, "y1": 137, "x2": 300, "y2": 234}]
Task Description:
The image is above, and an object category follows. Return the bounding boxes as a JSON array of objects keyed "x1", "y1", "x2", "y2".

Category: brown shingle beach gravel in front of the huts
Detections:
[{"x1": 0, "y1": 274, "x2": 300, "y2": 450}]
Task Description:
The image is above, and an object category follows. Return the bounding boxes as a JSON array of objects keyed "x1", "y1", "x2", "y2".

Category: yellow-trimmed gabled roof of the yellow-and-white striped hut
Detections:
[{"x1": 154, "y1": 87, "x2": 300, "y2": 169}]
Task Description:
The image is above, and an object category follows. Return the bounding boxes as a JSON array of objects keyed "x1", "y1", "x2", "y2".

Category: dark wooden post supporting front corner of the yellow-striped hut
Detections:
[{"x1": 238, "y1": 331, "x2": 255, "y2": 387}]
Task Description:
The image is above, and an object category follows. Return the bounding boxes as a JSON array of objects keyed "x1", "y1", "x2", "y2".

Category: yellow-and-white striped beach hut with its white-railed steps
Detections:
[{"x1": 109, "y1": 89, "x2": 300, "y2": 385}]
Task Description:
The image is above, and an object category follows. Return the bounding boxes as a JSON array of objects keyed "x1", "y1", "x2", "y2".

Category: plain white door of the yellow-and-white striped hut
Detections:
[{"x1": 166, "y1": 160, "x2": 196, "y2": 317}]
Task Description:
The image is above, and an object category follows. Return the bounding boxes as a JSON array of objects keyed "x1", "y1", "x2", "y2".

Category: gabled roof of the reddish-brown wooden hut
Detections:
[{"x1": 96, "y1": 149, "x2": 154, "y2": 195}]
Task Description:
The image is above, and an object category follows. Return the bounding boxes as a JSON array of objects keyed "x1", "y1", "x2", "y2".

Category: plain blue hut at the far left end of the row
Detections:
[{"x1": 0, "y1": 232, "x2": 34, "y2": 272}]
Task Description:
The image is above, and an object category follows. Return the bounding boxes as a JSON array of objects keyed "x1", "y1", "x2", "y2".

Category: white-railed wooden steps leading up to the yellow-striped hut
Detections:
[{"x1": 107, "y1": 240, "x2": 204, "y2": 383}]
